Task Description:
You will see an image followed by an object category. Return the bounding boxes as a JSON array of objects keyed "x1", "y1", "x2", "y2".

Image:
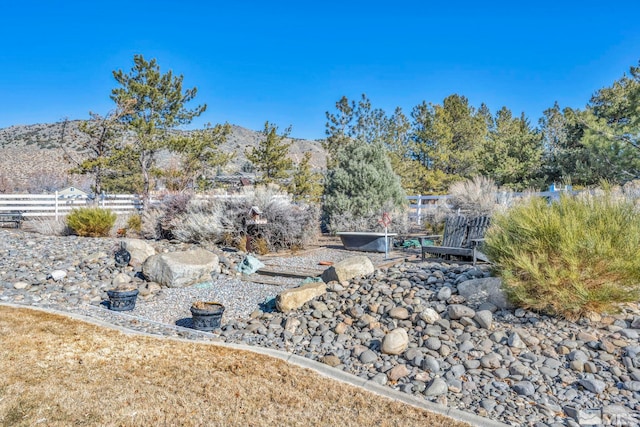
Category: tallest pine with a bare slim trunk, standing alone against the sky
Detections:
[{"x1": 111, "y1": 55, "x2": 206, "y2": 208}]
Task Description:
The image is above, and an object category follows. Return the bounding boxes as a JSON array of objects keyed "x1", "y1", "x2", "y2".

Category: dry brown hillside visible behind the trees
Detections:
[{"x1": 0, "y1": 120, "x2": 326, "y2": 192}]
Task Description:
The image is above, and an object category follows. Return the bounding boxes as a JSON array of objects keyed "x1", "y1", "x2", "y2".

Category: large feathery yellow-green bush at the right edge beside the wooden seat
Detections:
[{"x1": 484, "y1": 193, "x2": 640, "y2": 320}]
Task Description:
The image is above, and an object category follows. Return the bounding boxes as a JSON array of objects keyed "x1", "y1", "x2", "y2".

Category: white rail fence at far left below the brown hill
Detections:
[{"x1": 0, "y1": 192, "x2": 142, "y2": 219}]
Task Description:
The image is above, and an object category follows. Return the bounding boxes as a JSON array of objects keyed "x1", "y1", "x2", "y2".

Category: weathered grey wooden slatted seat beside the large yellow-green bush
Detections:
[{"x1": 422, "y1": 215, "x2": 491, "y2": 265}]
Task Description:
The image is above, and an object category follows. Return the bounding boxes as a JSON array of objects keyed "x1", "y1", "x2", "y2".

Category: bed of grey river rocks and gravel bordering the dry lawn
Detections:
[{"x1": 0, "y1": 229, "x2": 640, "y2": 426}]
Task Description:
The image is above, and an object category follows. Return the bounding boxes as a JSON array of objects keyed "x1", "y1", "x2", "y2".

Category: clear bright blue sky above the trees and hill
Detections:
[{"x1": 0, "y1": 0, "x2": 640, "y2": 139}]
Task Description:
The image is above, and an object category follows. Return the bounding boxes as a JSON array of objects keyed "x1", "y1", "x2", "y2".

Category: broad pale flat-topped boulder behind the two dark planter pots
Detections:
[{"x1": 142, "y1": 249, "x2": 220, "y2": 288}]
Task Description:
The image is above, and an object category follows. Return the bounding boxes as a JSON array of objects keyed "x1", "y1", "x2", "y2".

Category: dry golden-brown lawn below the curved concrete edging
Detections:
[{"x1": 0, "y1": 306, "x2": 466, "y2": 426}]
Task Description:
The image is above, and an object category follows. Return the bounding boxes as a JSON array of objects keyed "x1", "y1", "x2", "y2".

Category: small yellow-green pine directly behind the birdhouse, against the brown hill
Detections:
[{"x1": 245, "y1": 122, "x2": 293, "y2": 184}]
